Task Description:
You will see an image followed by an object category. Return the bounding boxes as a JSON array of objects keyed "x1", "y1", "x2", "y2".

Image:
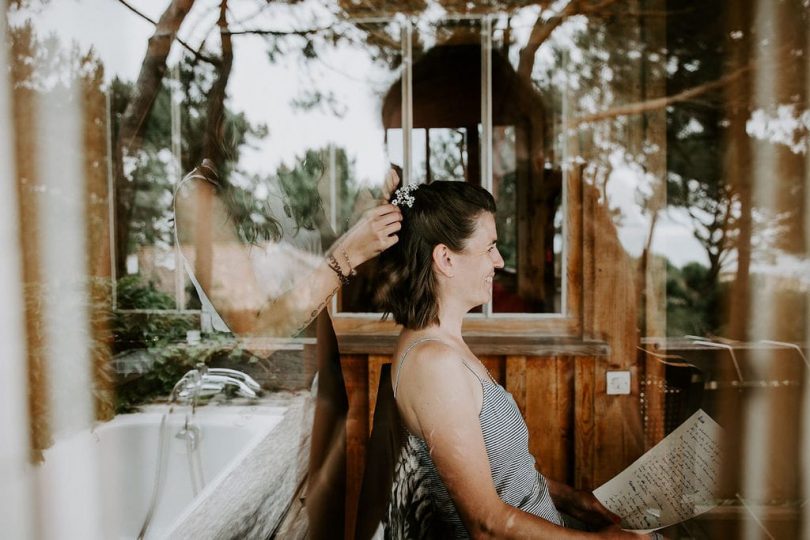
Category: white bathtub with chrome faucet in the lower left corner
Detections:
[{"x1": 39, "y1": 406, "x2": 286, "y2": 539}]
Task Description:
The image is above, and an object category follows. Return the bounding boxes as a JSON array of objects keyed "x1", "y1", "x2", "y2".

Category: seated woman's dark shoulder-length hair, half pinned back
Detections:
[{"x1": 377, "y1": 181, "x2": 495, "y2": 330}]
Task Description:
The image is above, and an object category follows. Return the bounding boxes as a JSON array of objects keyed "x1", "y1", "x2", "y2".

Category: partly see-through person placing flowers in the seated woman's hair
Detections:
[{"x1": 174, "y1": 160, "x2": 401, "y2": 338}]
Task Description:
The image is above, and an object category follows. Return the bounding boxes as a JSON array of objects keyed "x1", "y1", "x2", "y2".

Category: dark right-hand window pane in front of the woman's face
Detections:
[{"x1": 492, "y1": 17, "x2": 565, "y2": 313}]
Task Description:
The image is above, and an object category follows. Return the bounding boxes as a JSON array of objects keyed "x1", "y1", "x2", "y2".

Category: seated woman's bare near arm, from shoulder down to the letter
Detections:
[{"x1": 397, "y1": 342, "x2": 638, "y2": 539}]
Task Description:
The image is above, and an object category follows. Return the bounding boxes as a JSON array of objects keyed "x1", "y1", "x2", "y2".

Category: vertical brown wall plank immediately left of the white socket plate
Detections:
[{"x1": 574, "y1": 357, "x2": 597, "y2": 489}]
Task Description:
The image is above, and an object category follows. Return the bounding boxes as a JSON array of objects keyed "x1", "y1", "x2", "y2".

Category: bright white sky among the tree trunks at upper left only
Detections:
[{"x1": 19, "y1": 0, "x2": 398, "y2": 184}]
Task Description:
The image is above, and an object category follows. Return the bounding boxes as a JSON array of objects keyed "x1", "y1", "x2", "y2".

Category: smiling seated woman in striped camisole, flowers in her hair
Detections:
[{"x1": 380, "y1": 182, "x2": 638, "y2": 538}]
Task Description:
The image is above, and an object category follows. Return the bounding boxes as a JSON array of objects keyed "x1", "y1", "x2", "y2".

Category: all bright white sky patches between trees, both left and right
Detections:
[{"x1": 12, "y1": 0, "x2": 708, "y2": 266}]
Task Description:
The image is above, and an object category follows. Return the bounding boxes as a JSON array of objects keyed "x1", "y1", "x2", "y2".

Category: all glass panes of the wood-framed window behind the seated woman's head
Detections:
[{"x1": 340, "y1": 12, "x2": 565, "y2": 314}]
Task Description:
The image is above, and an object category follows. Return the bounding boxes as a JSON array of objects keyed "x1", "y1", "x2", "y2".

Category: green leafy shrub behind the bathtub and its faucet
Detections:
[{"x1": 113, "y1": 276, "x2": 248, "y2": 414}]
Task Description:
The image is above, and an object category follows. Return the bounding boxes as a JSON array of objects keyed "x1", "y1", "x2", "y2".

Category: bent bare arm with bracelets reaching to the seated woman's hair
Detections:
[{"x1": 175, "y1": 171, "x2": 401, "y2": 337}]
